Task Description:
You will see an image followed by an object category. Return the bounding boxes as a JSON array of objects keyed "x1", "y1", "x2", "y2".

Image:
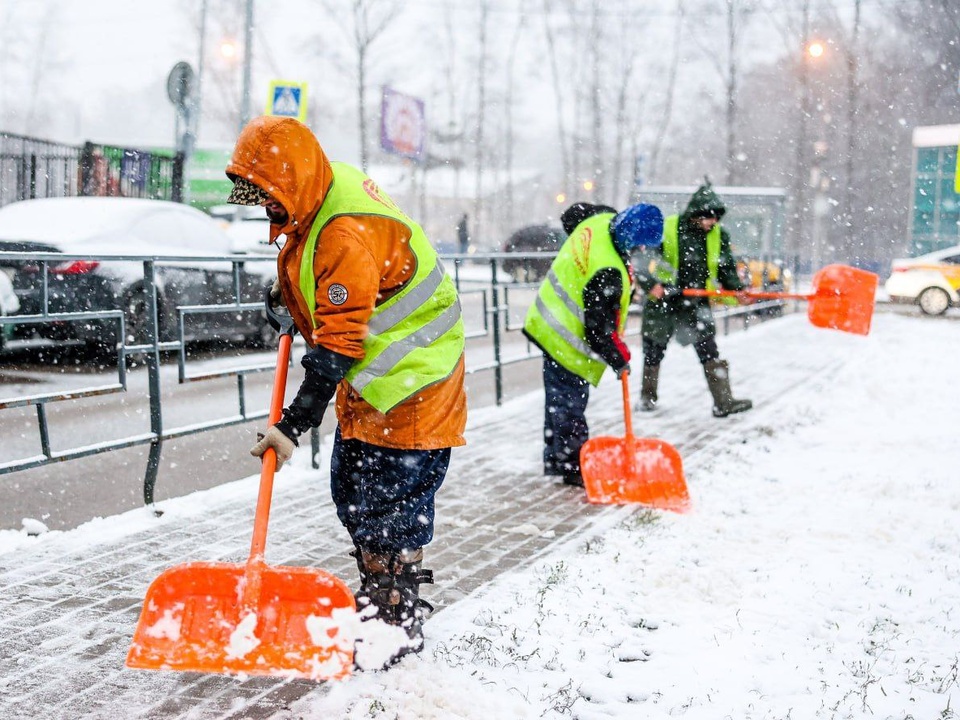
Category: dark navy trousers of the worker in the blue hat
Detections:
[{"x1": 543, "y1": 355, "x2": 590, "y2": 475}]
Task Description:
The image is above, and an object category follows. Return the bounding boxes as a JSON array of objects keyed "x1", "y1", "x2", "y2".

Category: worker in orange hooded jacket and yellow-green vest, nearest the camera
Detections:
[{"x1": 227, "y1": 117, "x2": 466, "y2": 660}]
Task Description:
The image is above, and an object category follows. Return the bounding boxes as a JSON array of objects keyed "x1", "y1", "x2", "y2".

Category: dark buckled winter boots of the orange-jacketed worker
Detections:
[{"x1": 351, "y1": 548, "x2": 433, "y2": 663}]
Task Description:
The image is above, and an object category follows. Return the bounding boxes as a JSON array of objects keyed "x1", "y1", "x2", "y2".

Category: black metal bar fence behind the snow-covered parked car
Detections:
[{"x1": 0, "y1": 132, "x2": 183, "y2": 207}]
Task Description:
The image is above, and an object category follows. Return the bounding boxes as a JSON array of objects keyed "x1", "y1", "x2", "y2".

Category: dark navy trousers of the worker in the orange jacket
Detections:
[{"x1": 330, "y1": 428, "x2": 450, "y2": 555}]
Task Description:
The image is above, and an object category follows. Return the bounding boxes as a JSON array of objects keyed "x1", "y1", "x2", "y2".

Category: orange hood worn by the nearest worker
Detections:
[{"x1": 227, "y1": 116, "x2": 333, "y2": 242}]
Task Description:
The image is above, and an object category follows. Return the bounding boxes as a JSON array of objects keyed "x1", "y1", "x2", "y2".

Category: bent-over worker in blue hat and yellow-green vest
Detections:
[{"x1": 523, "y1": 204, "x2": 663, "y2": 486}]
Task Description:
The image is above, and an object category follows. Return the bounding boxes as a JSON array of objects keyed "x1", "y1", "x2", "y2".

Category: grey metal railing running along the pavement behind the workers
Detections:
[{"x1": 0, "y1": 252, "x2": 780, "y2": 505}]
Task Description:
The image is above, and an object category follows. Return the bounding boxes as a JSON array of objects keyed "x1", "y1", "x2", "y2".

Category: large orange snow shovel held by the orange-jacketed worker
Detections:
[{"x1": 127, "y1": 292, "x2": 356, "y2": 680}]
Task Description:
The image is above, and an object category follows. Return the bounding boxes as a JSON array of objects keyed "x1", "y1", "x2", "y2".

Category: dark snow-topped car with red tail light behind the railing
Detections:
[{"x1": 0, "y1": 197, "x2": 269, "y2": 348}]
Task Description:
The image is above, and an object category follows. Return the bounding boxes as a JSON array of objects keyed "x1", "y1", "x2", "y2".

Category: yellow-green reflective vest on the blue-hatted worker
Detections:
[{"x1": 524, "y1": 213, "x2": 631, "y2": 385}]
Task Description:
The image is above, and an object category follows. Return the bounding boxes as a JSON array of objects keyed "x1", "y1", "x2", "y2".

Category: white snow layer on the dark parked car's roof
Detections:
[{"x1": 0, "y1": 197, "x2": 191, "y2": 243}]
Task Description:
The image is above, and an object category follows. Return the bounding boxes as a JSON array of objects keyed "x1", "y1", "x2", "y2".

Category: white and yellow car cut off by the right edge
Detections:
[{"x1": 884, "y1": 245, "x2": 960, "y2": 315}]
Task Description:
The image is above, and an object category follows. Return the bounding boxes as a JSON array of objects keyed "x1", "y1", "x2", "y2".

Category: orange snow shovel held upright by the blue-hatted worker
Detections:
[{"x1": 580, "y1": 372, "x2": 690, "y2": 512}]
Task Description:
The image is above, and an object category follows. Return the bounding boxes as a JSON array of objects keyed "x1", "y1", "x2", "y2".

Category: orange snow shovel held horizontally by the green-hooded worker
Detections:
[{"x1": 683, "y1": 265, "x2": 880, "y2": 335}]
